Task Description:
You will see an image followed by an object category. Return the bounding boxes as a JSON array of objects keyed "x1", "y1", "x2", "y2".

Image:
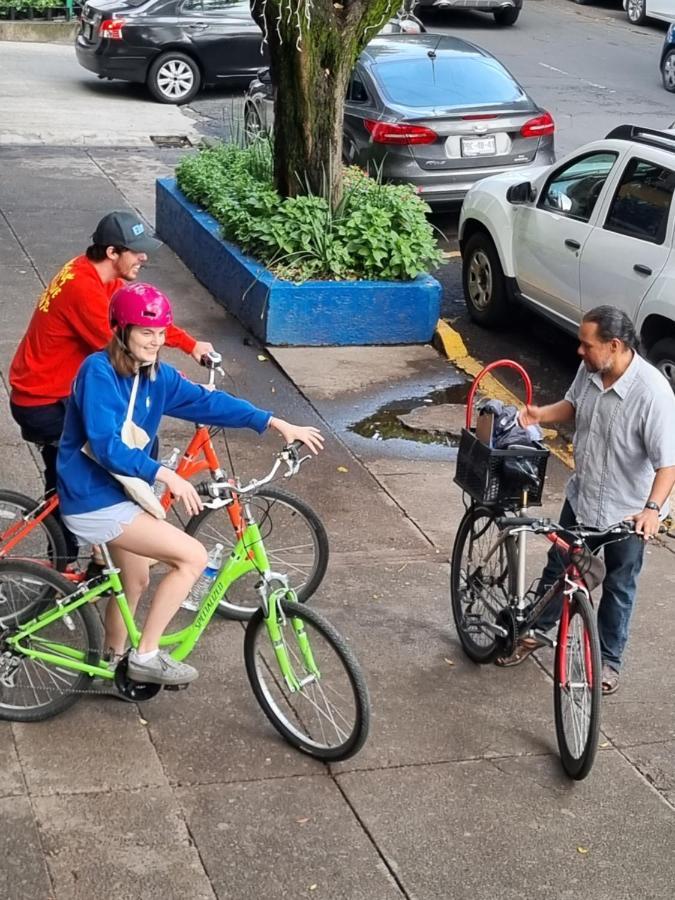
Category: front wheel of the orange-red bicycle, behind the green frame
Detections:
[{"x1": 185, "y1": 488, "x2": 328, "y2": 621}]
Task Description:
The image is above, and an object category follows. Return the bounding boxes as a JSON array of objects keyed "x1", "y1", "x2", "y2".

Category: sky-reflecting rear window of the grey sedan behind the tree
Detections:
[{"x1": 373, "y1": 56, "x2": 531, "y2": 108}]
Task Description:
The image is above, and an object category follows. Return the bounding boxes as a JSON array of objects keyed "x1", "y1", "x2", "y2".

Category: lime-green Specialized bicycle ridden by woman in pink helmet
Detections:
[{"x1": 0, "y1": 445, "x2": 370, "y2": 762}]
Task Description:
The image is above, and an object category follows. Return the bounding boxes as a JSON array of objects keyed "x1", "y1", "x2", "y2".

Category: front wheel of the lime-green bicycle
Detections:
[{"x1": 244, "y1": 601, "x2": 370, "y2": 762}]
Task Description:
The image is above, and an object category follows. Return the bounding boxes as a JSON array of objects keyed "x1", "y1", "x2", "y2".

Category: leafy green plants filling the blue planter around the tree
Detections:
[{"x1": 176, "y1": 139, "x2": 440, "y2": 281}]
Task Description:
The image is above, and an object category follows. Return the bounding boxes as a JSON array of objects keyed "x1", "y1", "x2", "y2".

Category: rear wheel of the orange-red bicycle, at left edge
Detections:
[{"x1": 0, "y1": 490, "x2": 68, "y2": 572}]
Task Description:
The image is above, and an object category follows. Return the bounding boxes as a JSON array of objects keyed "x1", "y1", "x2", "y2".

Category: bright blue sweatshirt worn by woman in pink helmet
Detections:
[{"x1": 56, "y1": 351, "x2": 272, "y2": 515}]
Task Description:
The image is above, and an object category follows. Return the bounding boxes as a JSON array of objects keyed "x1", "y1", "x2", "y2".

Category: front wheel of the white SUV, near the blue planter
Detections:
[{"x1": 462, "y1": 231, "x2": 509, "y2": 327}]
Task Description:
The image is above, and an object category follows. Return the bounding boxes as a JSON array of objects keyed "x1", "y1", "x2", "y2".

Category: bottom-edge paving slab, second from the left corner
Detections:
[{"x1": 34, "y1": 788, "x2": 215, "y2": 900}]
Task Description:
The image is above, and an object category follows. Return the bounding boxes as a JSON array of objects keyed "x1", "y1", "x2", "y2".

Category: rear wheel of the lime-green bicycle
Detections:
[{"x1": 0, "y1": 559, "x2": 101, "y2": 722}]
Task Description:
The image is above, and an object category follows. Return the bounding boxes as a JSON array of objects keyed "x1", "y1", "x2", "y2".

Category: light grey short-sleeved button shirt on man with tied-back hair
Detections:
[{"x1": 565, "y1": 353, "x2": 675, "y2": 528}]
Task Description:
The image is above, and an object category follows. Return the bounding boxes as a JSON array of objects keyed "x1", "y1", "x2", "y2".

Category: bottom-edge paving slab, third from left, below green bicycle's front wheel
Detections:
[{"x1": 177, "y1": 777, "x2": 402, "y2": 900}]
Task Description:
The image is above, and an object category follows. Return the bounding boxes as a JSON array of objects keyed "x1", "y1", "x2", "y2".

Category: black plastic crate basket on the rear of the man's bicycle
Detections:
[{"x1": 455, "y1": 428, "x2": 549, "y2": 506}]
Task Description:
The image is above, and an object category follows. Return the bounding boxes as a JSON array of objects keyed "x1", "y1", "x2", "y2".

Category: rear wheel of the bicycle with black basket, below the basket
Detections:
[{"x1": 450, "y1": 504, "x2": 517, "y2": 665}]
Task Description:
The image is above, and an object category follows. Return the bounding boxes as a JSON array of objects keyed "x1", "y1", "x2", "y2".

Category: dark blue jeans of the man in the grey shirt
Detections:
[{"x1": 537, "y1": 500, "x2": 645, "y2": 672}]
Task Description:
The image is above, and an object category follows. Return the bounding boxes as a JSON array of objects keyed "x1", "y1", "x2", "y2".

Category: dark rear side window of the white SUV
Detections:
[{"x1": 605, "y1": 159, "x2": 675, "y2": 244}]
